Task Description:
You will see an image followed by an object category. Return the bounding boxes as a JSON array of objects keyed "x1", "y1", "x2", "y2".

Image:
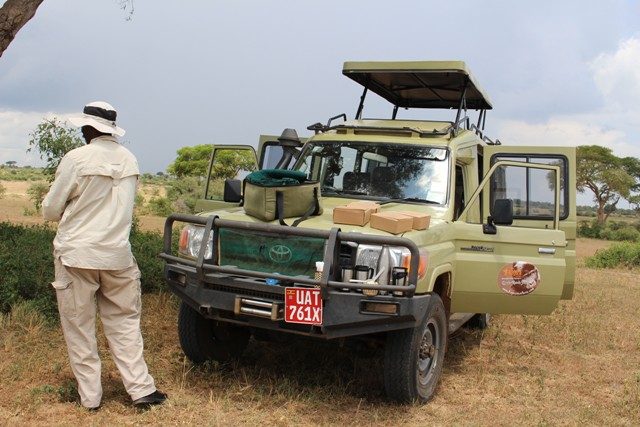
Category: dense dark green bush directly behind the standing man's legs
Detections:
[{"x1": 0, "y1": 222, "x2": 166, "y2": 320}]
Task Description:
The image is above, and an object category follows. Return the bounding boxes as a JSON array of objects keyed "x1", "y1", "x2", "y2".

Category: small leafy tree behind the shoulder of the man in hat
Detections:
[{"x1": 27, "y1": 117, "x2": 84, "y2": 181}]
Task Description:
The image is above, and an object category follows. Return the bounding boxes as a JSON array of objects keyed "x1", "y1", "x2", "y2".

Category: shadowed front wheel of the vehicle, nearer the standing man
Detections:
[{"x1": 178, "y1": 301, "x2": 251, "y2": 363}]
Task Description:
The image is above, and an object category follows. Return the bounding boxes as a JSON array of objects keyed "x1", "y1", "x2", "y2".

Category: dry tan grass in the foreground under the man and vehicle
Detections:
[{"x1": 0, "y1": 239, "x2": 640, "y2": 425}]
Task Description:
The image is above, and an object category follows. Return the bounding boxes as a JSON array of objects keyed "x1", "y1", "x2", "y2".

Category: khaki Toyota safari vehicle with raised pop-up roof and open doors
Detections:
[{"x1": 161, "y1": 61, "x2": 576, "y2": 402}]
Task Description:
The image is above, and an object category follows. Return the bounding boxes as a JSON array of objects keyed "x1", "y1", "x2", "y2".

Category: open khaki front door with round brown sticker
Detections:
[{"x1": 451, "y1": 159, "x2": 566, "y2": 314}]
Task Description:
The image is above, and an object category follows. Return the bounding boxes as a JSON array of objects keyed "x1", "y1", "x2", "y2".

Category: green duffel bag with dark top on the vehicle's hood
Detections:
[{"x1": 243, "y1": 169, "x2": 322, "y2": 227}]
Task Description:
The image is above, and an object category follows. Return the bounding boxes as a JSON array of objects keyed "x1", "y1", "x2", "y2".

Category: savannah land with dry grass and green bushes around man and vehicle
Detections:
[{"x1": 0, "y1": 123, "x2": 640, "y2": 425}]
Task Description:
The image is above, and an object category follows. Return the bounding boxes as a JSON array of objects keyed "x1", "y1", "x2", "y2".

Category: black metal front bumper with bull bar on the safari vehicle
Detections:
[{"x1": 160, "y1": 214, "x2": 430, "y2": 339}]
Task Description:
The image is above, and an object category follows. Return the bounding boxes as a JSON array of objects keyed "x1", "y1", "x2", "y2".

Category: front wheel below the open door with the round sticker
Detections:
[{"x1": 384, "y1": 294, "x2": 449, "y2": 403}]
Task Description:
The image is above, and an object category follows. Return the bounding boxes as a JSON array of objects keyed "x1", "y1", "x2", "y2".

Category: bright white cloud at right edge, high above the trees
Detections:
[{"x1": 589, "y1": 37, "x2": 640, "y2": 111}]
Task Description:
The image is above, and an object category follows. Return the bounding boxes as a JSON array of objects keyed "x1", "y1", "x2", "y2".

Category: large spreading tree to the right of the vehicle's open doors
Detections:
[{"x1": 576, "y1": 145, "x2": 640, "y2": 225}]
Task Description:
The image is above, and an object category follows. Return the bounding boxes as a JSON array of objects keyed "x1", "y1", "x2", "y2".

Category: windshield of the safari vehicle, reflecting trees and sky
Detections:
[{"x1": 296, "y1": 142, "x2": 449, "y2": 204}]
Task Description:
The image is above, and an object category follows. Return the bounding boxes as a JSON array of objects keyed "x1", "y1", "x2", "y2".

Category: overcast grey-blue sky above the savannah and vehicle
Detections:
[{"x1": 0, "y1": 0, "x2": 640, "y2": 192}]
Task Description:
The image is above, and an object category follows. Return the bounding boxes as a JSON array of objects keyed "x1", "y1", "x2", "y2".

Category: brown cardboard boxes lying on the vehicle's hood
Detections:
[{"x1": 333, "y1": 201, "x2": 431, "y2": 234}]
